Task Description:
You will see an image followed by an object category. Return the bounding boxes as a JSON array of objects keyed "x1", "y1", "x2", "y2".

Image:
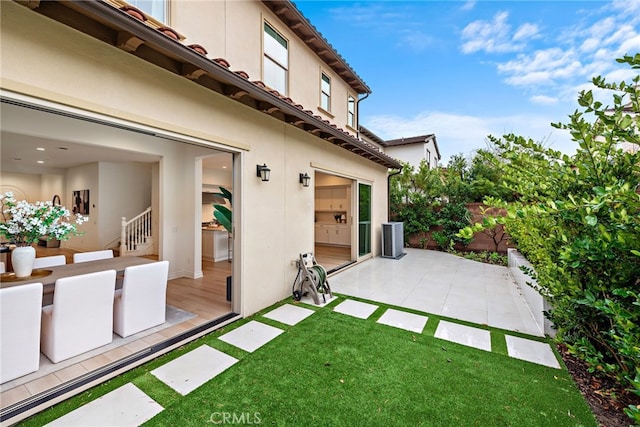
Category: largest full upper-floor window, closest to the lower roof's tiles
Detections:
[{"x1": 263, "y1": 22, "x2": 289, "y2": 95}]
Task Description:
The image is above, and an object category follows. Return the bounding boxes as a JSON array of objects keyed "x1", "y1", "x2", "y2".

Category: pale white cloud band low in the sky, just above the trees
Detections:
[{"x1": 365, "y1": 111, "x2": 575, "y2": 164}]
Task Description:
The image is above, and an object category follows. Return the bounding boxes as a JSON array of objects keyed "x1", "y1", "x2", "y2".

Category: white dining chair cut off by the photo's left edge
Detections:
[{"x1": 0, "y1": 283, "x2": 42, "y2": 383}]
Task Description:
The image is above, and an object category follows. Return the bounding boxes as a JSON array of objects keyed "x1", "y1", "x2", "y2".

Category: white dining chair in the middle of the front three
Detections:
[{"x1": 40, "y1": 270, "x2": 116, "y2": 363}]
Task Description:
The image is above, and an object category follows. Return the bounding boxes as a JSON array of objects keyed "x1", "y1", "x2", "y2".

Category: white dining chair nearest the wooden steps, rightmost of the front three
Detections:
[{"x1": 113, "y1": 261, "x2": 169, "y2": 337}]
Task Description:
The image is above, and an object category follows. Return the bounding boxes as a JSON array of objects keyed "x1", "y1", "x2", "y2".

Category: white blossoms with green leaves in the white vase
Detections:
[{"x1": 0, "y1": 192, "x2": 88, "y2": 246}]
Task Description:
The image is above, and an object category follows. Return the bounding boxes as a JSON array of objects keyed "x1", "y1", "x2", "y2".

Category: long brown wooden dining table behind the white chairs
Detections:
[{"x1": 0, "y1": 256, "x2": 157, "y2": 305}]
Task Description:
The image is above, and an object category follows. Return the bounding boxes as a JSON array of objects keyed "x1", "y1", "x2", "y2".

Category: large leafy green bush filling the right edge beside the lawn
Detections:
[{"x1": 461, "y1": 54, "x2": 640, "y2": 421}]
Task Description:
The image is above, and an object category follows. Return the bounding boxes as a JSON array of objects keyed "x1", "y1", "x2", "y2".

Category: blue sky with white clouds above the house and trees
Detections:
[{"x1": 295, "y1": 0, "x2": 640, "y2": 165}]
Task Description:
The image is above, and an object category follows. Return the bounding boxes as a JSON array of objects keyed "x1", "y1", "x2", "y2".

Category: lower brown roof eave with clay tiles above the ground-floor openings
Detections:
[{"x1": 21, "y1": 1, "x2": 402, "y2": 169}]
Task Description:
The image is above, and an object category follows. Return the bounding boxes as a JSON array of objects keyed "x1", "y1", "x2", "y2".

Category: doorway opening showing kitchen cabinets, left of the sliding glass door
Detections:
[{"x1": 314, "y1": 171, "x2": 356, "y2": 272}]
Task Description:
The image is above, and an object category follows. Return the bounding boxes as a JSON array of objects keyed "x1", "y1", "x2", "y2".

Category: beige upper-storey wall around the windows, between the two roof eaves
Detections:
[{"x1": 171, "y1": 1, "x2": 358, "y2": 135}]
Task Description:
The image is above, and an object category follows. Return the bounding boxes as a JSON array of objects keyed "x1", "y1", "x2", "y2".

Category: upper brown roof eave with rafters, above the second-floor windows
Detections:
[{"x1": 262, "y1": 0, "x2": 371, "y2": 94}]
